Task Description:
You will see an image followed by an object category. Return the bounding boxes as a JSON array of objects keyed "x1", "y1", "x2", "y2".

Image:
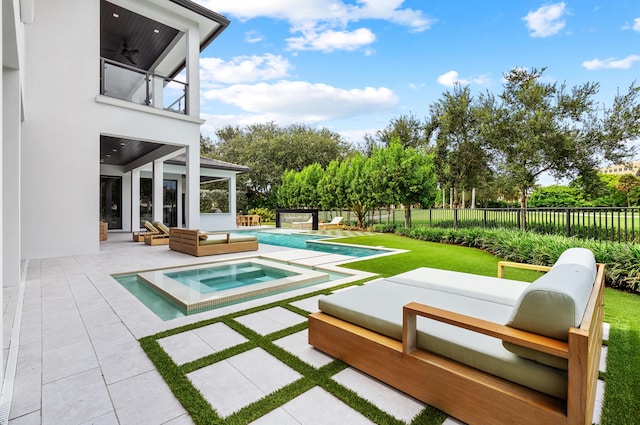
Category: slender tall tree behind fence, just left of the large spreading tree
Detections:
[{"x1": 428, "y1": 85, "x2": 490, "y2": 208}]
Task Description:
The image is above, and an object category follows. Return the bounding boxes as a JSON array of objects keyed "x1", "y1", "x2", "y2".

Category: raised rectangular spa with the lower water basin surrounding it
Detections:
[{"x1": 113, "y1": 257, "x2": 351, "y2": 320}]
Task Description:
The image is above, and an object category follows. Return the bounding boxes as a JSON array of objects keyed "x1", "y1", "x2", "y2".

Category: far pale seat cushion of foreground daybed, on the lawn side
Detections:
[{"x1": 387, "y1": 267, "x2": 529, "y2": 307}]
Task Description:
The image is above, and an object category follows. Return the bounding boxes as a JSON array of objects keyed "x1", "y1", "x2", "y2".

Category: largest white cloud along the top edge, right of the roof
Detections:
[{"x1": 197, "y1": 0, "x2": 434, "y2": 54}]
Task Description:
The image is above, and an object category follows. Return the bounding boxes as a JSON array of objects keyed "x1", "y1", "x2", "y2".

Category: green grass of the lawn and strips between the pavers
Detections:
[{"x1": 140, "y1": 234, "x2": 640, "y2": 425}]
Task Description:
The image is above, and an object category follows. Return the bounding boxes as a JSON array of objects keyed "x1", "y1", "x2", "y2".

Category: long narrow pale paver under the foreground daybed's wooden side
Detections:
[{"x1": 333, "y1": 367, "x2": 425, "y2": 422}]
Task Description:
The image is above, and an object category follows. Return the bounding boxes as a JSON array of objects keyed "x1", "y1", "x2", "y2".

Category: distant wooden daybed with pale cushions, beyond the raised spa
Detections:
[{"x1": 169, "y1": 227, "x2": 258, "y2": 257}]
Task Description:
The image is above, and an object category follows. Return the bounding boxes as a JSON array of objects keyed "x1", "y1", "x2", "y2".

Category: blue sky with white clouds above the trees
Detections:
[{"x1": 196, "y1": 0, "x2": 640, "y2": 152}]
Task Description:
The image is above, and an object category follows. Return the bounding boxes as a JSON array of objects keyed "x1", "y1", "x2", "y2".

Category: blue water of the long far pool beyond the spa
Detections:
[{"x1": 238, "y1": 230, "x2": 386, "y2": 258}]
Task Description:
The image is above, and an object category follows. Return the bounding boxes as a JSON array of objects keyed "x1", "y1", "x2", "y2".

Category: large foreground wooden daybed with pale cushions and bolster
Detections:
[{"x1": 309, "y1": 248, "x2": 604, "y2": 425}]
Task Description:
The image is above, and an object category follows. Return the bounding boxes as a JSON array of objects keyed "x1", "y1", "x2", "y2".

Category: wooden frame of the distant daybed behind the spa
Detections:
[{"x1": 169, "y1": 227, "x2": 258, "y2": 257}]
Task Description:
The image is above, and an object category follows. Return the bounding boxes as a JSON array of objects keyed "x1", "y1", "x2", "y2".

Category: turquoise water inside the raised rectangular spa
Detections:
[{"x1": 165, "y1": 262, "x2": 299, "y2": 294}]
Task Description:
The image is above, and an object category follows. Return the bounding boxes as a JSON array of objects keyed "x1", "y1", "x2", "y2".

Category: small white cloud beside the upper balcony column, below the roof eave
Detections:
[{"x1": 200, "y1": 53, "x2": 292, "y2": 87}]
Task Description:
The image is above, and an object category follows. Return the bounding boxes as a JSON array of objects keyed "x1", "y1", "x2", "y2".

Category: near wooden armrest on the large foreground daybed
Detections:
[{"x1": 402, "y1": 302, "x2": 569, "y2": 359}]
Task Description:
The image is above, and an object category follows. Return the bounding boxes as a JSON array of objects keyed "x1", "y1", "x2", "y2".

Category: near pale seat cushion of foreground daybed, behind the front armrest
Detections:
[{"x1": 318, "y1": 279, "x2": 567, "y2": 399}]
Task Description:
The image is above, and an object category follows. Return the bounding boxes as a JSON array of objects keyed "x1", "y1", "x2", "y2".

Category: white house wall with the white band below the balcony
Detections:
[{"x1": 21, "y1": 0, "x2": 201, "y2": 258}]
